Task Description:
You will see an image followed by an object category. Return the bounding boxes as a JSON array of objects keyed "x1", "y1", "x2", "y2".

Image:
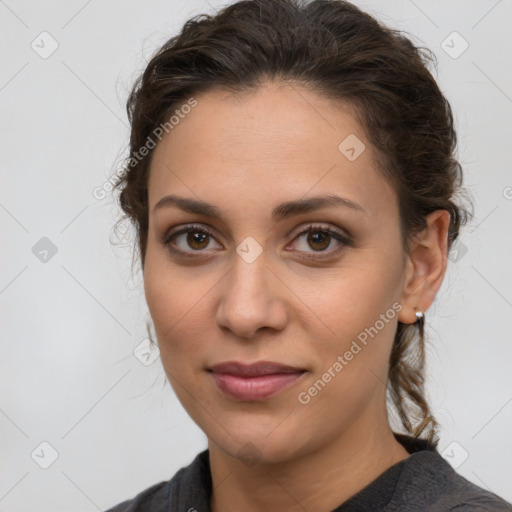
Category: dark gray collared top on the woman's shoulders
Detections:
[{"x1": 106, "y1": 433, "x2": 512, "y2": 512}]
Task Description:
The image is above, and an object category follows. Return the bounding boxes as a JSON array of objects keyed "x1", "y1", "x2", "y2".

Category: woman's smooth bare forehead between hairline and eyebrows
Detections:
[{"x1": 148, "y1": 83, "x2": 396, "y2": 222}]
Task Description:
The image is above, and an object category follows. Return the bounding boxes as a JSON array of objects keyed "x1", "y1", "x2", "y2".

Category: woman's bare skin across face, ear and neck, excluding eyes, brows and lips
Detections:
[{"x1": 144, "y1": 82, "x2": 449, "y2": 512}]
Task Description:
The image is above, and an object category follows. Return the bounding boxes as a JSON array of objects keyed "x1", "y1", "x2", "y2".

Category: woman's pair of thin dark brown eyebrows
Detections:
[{"x1": 153, "y1": 195, "x2": 367, "y2": 222}]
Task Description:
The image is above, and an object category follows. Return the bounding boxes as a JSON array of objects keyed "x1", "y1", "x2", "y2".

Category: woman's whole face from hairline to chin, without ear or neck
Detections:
[{"x1": 144, "y1": 83, "x2": 410, "y2": 462}]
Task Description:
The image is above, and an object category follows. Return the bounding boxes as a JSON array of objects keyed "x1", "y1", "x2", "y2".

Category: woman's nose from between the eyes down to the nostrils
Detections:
[{"x1": 216, "y1": 249, "x2": 288, "y2": 339}]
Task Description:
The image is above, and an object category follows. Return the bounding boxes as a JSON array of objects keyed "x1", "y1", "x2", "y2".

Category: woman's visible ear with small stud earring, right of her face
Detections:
[{"x1": 398, "y1": 210, "x2": 450, "y2": 324}]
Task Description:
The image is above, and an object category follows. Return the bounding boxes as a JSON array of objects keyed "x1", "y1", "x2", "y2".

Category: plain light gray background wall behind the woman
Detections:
[{"x1": 0, "y1": 0, "x2": 512, "y2": 512}]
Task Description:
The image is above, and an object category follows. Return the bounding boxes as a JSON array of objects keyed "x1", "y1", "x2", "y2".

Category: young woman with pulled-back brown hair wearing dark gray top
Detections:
[{"x1": 105, "y1": 0, "x2": 512, "y2": 512}]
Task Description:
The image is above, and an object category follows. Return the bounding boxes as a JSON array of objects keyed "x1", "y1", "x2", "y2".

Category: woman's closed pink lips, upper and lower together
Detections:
[{"x1": 208, "y1": 361, "x2": 306, "y2": 401}]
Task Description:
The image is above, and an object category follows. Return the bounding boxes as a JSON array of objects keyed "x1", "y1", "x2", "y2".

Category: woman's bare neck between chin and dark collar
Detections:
[{"x1": 209, "y1": 414, "x2": 409, "y2": 512}]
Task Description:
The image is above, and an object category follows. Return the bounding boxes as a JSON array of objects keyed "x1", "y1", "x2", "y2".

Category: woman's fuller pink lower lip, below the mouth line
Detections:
[{"x1": 212, "y1": 372, "x2": 304, "y2": 400}]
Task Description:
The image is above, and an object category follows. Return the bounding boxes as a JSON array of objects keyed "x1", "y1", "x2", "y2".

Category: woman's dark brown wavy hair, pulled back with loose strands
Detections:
[{"x1": 114, "y1": 0, "x2": 471, "y2": 444}]
